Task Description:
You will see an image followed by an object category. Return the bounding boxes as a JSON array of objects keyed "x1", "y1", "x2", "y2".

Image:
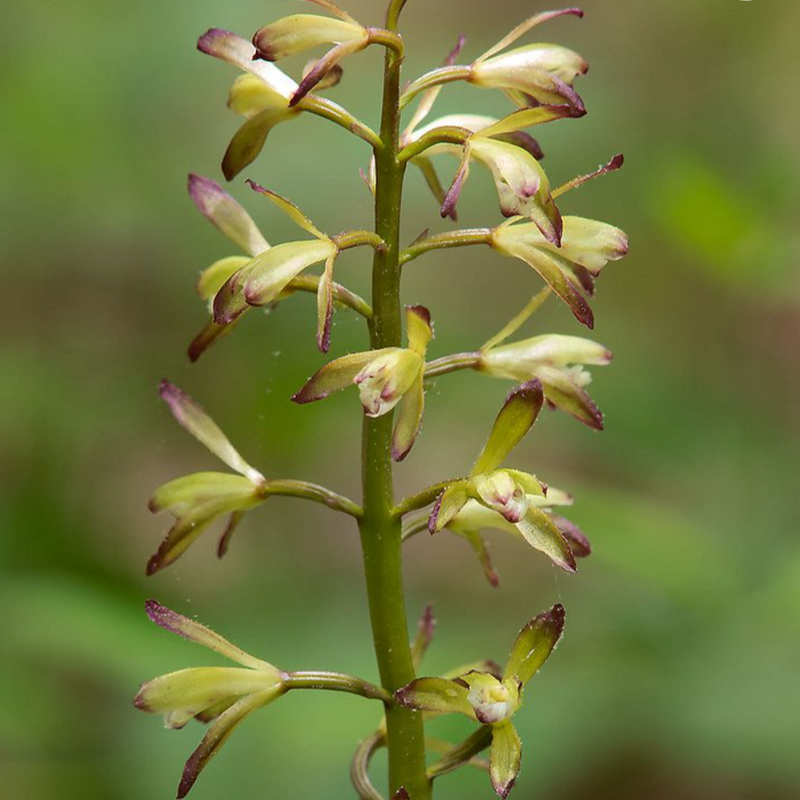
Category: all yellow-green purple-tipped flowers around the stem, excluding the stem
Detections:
[{"x1": 136, "y1": 0, "x2": 628, "y2": 797}]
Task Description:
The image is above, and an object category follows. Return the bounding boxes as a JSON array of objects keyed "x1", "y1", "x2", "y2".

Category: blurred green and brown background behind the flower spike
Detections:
[{"x1": 0, "y1": 0, "x2": 800, "y2": 800}]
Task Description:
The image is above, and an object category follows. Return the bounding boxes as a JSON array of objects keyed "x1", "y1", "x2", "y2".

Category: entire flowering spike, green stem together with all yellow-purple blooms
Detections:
[{"x1": 134, "y1": 0, "x2": 628, "y2": 800}]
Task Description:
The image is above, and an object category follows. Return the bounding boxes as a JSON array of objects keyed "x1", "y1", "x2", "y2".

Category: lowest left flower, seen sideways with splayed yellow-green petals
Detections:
[{"x1": 133, "y1": 600, "x2": 286, "y2": 798}]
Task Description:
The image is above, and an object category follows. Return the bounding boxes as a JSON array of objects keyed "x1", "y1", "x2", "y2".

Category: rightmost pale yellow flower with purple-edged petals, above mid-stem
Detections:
[{"x1": 492, "y1": 212, "x2": 628, "y2": 328}]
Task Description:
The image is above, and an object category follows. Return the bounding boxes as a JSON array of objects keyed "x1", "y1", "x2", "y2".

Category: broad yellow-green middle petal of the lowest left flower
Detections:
[{"x1": 133, "y1": 667, "x2": 281, "y2": 724}]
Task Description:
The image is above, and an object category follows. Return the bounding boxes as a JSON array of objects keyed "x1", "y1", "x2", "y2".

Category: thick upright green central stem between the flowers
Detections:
[{"x1": 359, "y1": 14, "x2": 431, "y2": 800}]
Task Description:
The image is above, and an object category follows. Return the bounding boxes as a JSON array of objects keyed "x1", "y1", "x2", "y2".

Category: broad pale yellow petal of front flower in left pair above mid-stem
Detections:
[{"x1": 242, "y1": 239, "x2": 338, "y2": 306}]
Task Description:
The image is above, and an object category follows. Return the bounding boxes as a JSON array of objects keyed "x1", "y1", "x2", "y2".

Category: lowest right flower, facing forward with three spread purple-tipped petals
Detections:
[{"x1": 395, "y1": 605, "x2": 565, "y2": 798}]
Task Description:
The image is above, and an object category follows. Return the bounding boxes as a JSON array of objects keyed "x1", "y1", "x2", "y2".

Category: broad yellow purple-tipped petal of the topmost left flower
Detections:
[{"x1": 253, "y1": 14, "x2": 369, "y2": 61}]
